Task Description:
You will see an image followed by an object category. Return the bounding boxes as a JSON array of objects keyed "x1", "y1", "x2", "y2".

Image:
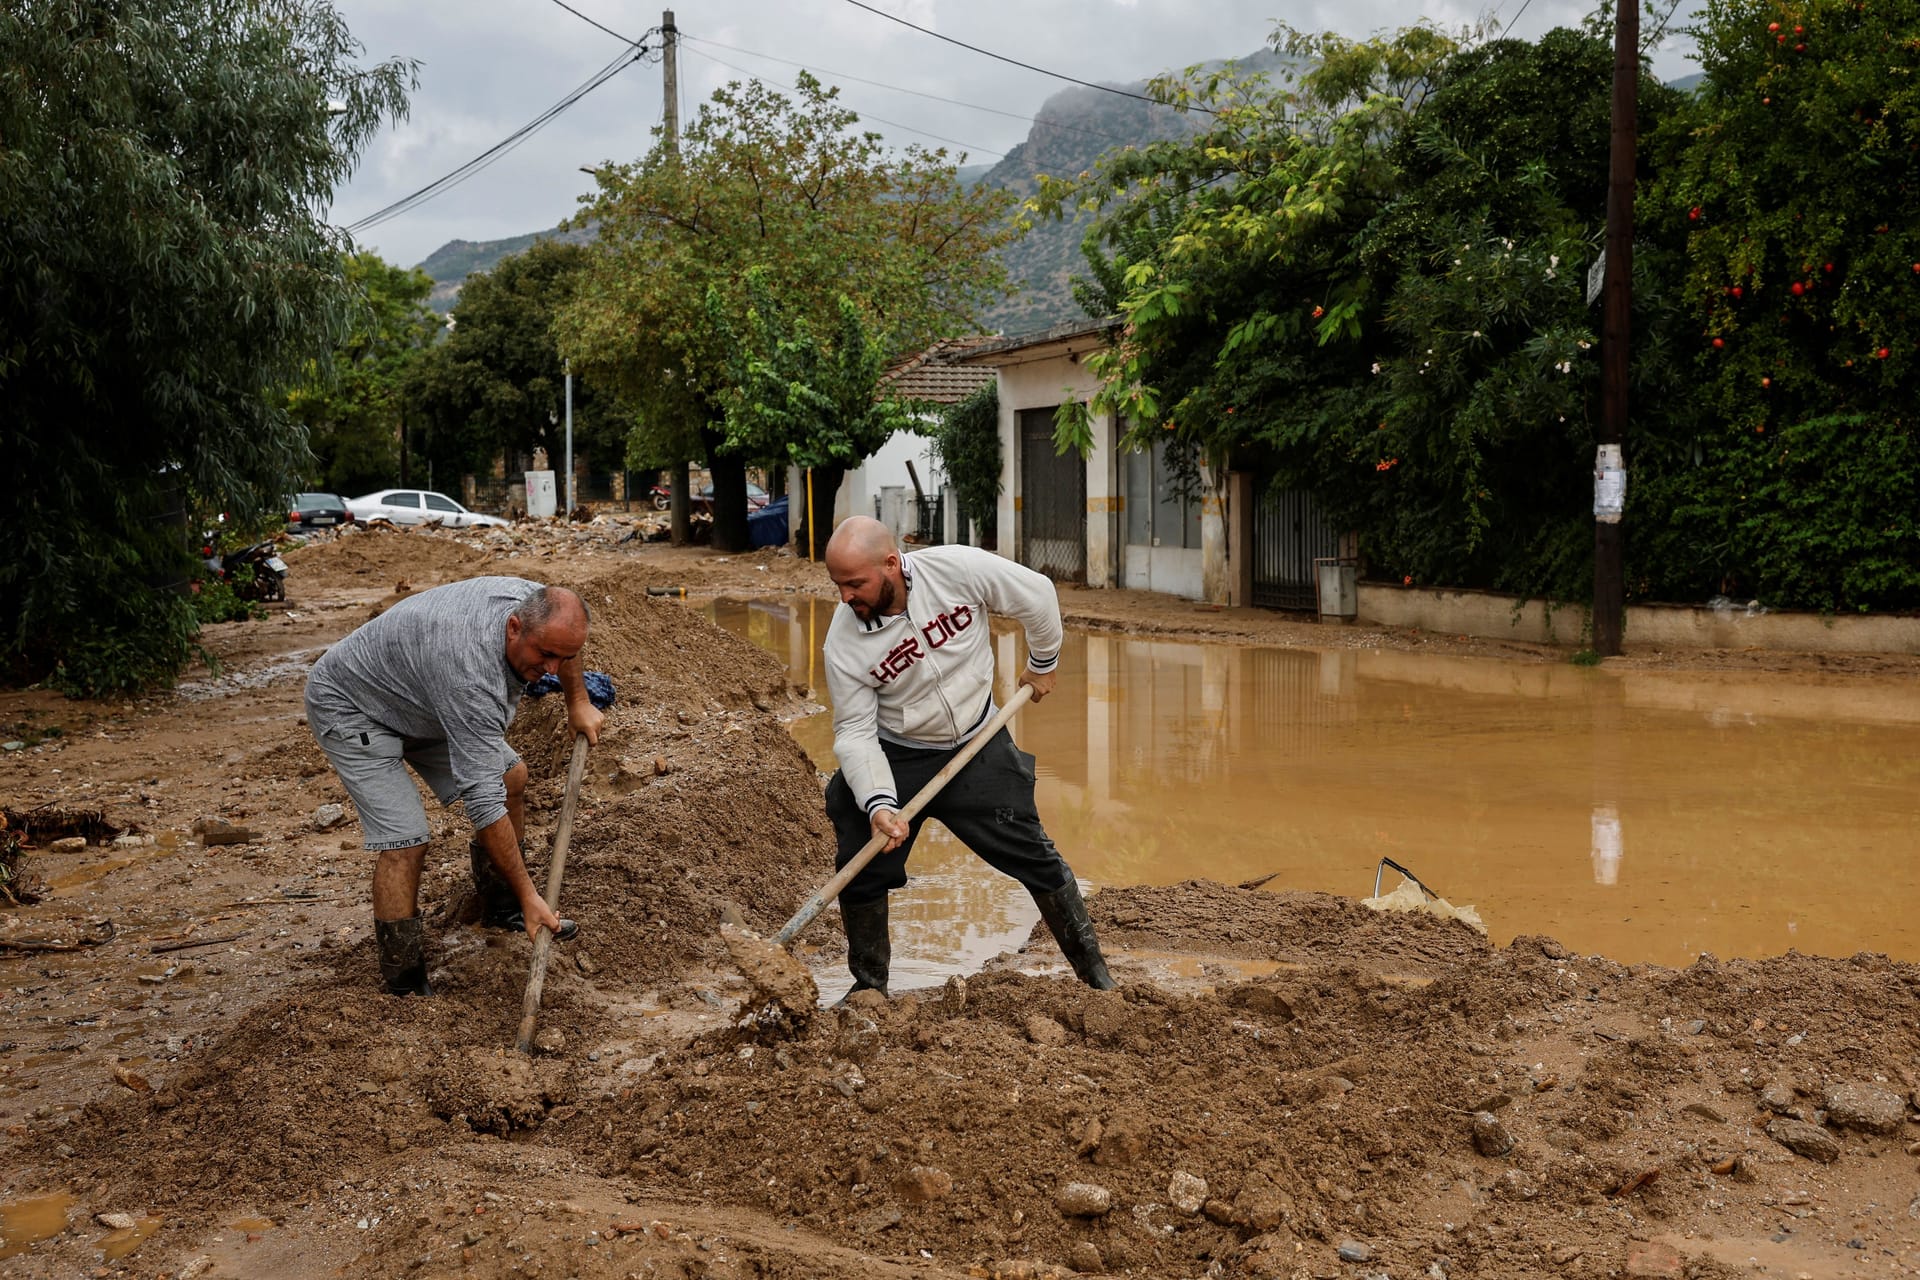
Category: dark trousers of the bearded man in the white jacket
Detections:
[{"x1": 828, "y1": 729, "x2": 1073, "y2": 904}]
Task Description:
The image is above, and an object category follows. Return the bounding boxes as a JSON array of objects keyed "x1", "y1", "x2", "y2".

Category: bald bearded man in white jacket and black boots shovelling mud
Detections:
[{"x1": 826, "y1": 516, "x2": 1114, "y2": 994}]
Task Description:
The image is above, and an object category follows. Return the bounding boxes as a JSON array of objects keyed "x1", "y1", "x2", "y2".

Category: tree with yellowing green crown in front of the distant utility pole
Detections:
[{"x1": 559, "y1": 75, "x2": 1016, "y2": 549}]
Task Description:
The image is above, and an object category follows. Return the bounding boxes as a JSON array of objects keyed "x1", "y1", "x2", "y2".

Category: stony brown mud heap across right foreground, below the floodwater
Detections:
[{"x1": 599, "y1": 909, "x2": 1920, "y2": 1278}]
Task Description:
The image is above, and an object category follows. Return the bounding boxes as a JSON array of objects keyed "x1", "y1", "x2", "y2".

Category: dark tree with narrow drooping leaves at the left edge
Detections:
[{"x1": 0, "y1": 0, "x2": 411, "y2": 693}]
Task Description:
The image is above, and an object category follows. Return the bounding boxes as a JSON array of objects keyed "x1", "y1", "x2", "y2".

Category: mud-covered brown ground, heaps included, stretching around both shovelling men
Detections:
[{"x1": 0, "y1": 524, "x2": 1920, "y2": 1280}]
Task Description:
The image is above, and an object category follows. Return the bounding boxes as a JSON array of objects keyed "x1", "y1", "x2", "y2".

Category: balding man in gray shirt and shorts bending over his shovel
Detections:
[{"x1": 307, "y1": 578, "x2": 605, "y2": 996}]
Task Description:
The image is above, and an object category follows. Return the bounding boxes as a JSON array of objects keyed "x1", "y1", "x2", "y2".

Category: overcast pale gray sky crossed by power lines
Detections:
[{"x1": 330, "y1": 0, "x2": 1699, "y2": 265}]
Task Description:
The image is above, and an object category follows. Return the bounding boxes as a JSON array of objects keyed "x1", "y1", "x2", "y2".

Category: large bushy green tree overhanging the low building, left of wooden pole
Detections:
[{"x1": 1041, "y1": 27, "x2": 1678, "y2": 595}]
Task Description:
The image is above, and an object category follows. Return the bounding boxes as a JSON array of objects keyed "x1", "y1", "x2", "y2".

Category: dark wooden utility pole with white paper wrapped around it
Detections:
[{"x1": 1594, "y1": 0, "x2": 1640, "y2": 658}]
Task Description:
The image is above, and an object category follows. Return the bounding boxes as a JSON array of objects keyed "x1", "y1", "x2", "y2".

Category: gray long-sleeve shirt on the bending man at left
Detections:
[{"x1": 307, "y1": 578, "x2": 540, "y2": 829}]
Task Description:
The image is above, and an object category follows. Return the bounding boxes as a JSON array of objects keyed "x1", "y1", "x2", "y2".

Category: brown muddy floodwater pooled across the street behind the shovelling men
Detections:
[{"x1": 708, "y1": 597, "x2": 1920, "y2": 984}]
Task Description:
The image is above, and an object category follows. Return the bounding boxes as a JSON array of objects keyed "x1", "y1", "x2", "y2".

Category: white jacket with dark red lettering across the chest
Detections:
[{"x1": 826, "y1": 547, "x2": 1060, "y2": 814}]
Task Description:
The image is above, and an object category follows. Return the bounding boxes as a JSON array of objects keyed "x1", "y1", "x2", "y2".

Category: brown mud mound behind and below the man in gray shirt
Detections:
[{"x1": 45, "y1": 564, "x2": 833, "y2": 1221}]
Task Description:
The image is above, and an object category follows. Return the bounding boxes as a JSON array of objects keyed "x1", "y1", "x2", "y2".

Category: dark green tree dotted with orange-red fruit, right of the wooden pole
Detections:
[{"x1": 1630, "y1": 0, "x2": 1920, "y2": 610}]
